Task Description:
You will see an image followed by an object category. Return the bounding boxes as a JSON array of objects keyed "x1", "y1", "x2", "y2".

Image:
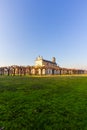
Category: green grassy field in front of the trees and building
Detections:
[{"x1": 0, "y1": 76, "x2": 87, "y2": 130}]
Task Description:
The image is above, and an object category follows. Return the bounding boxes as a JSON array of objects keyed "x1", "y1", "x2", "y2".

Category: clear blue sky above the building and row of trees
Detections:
[{"x1": 0, "y1": 0, "x2": 87, "y2": 68}]
